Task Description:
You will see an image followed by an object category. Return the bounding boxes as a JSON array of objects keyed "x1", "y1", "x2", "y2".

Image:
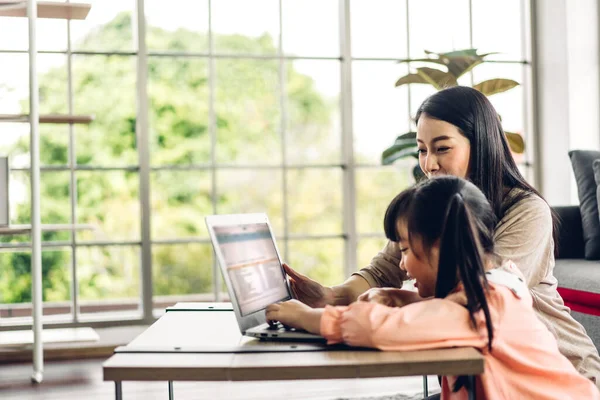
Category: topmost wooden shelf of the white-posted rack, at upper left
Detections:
[{"x1": 0, "y1": 0, "x2": 92, "y2": 19}]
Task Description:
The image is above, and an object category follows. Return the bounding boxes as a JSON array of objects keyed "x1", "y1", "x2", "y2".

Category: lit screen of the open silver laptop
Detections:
[{"x1": 214, "y1": 223, "x2": 290, "y2": 316}]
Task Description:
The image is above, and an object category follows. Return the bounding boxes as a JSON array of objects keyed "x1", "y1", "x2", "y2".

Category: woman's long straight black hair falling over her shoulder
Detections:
[{"x1": 415, "y1": 86, "x2": 558, "y2": 252}]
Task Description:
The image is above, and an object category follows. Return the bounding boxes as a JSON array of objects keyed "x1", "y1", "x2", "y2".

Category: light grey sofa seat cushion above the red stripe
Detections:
[{"x1": 554, "y1": 258, "x2": 600, "y2": 293}]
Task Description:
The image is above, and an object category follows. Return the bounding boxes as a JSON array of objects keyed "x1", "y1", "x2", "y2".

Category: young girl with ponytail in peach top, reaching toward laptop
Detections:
[{"x1": 267, "y1": 176, "x2": 600, "y2": 400}]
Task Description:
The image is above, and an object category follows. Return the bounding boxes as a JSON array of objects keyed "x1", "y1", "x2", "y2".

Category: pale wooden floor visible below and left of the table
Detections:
[{"x1": 0, "y1": 359, "x2": 439, "y2": 400}]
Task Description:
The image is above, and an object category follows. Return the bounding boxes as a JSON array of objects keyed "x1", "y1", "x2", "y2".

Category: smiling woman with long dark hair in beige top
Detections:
[{"x1": 285, "y1": 86, "x2": 600, "y2": 385}]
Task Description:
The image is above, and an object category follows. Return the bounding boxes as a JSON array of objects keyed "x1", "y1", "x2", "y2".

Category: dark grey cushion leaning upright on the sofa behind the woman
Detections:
[{"x1": 569, "y1": 150, "x2": 600, "y2": 260}]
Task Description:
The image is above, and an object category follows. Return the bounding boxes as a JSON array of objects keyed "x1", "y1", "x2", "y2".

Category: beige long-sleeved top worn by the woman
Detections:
[{"x1": 356, "y1": 195, "x2": 600, "y2": 387}]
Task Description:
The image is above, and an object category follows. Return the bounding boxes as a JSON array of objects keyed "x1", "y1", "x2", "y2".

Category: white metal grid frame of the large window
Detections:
[{"x1": 0, "y1": 0, "x2": 536, "y2": 329}]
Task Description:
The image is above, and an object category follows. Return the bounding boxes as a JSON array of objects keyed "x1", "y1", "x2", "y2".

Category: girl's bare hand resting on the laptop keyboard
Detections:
[{"x1": 266, "y1": 300, "x2": 323, "y2": 335}]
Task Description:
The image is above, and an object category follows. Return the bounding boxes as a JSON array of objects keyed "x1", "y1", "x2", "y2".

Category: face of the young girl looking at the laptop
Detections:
[{"x1": 397, "y1": 220, "x2": 440, "y2": 297}]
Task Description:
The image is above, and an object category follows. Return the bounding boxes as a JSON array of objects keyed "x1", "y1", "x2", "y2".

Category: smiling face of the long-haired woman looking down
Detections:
[{"x1": 417, "y1": 114, "x2": 471, "y2": 179}]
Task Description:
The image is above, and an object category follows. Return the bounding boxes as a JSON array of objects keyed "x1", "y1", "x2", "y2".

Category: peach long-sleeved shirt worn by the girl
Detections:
[{"x1": 321, "y1": 270, "x2": 600, "y2": 400}]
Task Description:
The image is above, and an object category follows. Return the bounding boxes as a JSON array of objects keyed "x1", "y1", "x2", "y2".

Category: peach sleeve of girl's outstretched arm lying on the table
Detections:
[{"x1": 320, "y1": 299, "x2": 487, "y2": 350}]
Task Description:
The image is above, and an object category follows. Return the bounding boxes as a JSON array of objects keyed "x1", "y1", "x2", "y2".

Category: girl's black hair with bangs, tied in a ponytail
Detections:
[{"x1": 383, "y1": 176, "x2": 497, "y2": 391}]
